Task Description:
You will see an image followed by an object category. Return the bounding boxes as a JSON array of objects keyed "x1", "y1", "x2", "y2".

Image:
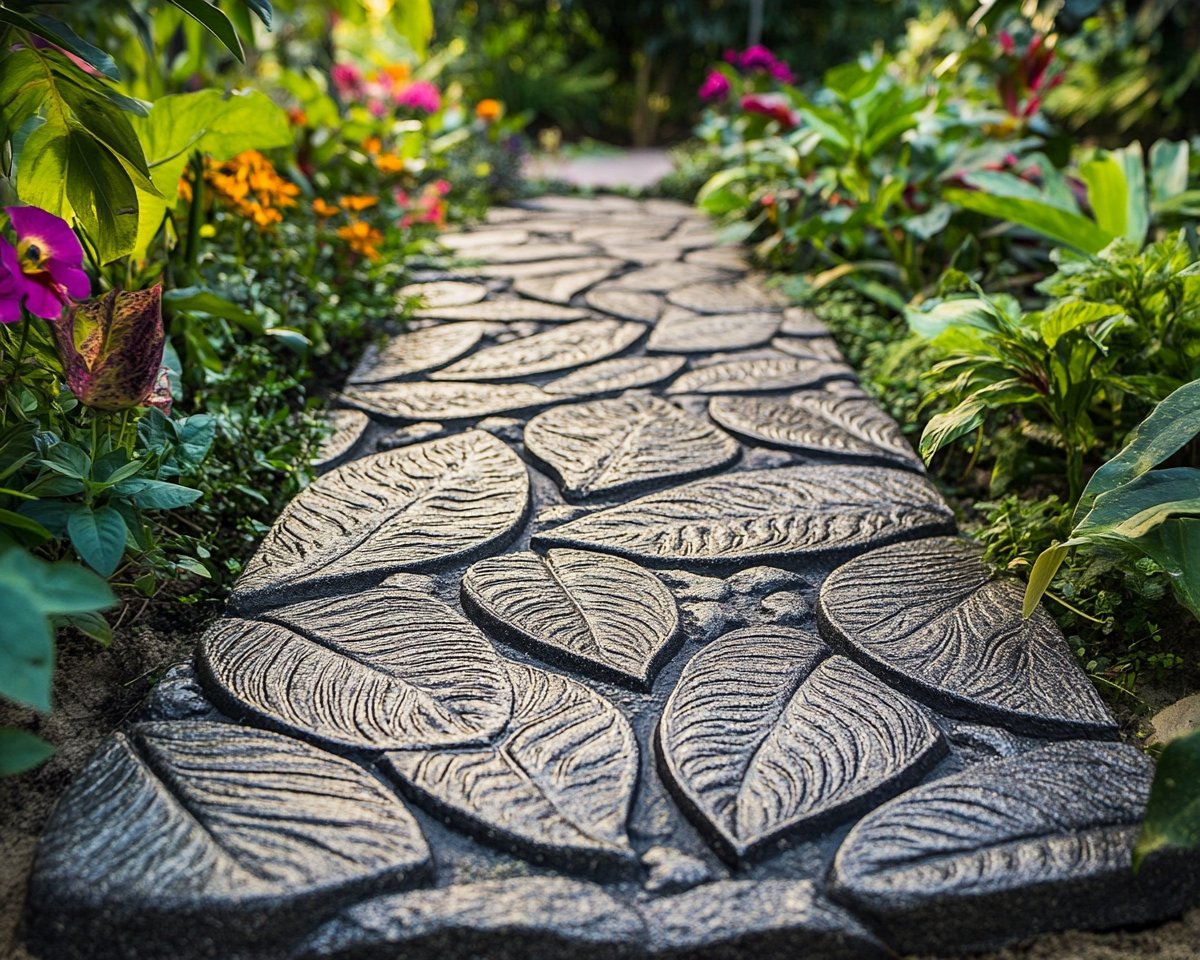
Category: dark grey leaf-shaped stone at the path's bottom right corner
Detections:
[{"x1": 832, "y1": 740, "x2": 1200, "y2": 955}]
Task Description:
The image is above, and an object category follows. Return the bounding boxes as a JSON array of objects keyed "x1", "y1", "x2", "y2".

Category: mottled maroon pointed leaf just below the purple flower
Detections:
[{"x1": 52, "y1": 286, "x2": 164, "y2": 410}]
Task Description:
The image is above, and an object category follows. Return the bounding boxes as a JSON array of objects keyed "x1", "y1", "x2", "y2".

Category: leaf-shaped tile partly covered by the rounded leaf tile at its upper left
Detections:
[{"x1": 383, "y1": 664, "x2": 637, "y2": 865}]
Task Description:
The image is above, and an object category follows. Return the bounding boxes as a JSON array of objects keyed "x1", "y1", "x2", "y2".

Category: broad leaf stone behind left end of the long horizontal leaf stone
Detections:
[{"x1": 524, "y1": 397, "x2": 739, "y2": 498}]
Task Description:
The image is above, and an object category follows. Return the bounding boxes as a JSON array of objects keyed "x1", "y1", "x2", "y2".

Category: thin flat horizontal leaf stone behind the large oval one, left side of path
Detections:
[{"x1": 342, "y1": 382, "x2": 554, "y2": 422}]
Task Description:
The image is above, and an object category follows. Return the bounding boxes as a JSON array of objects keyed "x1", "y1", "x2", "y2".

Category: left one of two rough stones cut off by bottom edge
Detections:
[{"x1": 296, "y1": 877, "x2": 646, "y2": 960}]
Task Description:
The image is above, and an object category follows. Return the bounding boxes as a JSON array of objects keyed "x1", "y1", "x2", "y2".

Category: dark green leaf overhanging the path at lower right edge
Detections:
[{"x1": 1134, "y1": 730, "x2": 1200, "y2": 868}]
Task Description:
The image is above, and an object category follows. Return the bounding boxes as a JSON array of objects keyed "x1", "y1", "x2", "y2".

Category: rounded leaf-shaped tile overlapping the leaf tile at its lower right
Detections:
[{"x1": 199, "y1": 575, "x2": 512, "y2": 750}]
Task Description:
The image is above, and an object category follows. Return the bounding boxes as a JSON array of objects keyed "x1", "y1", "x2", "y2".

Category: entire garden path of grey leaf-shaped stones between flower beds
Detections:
[{"x1": 21, "y1": 198, "x2": 1200, "y2": 960}]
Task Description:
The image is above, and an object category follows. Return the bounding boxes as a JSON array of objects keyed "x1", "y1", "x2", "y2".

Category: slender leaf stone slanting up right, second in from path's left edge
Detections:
[{"x1": 430, "y1": 319, "x2": 646, "y2": 380}]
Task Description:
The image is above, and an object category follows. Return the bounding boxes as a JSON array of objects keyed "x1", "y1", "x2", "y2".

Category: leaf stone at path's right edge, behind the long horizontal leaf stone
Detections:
[{"x1": 708, "y1": 390, "x2": 922, "y2": 470}]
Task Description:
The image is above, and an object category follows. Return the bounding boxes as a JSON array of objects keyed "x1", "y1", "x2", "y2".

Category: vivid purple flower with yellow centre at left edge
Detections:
[{"x1": 0, "y1": 206, "x2": 91, "y2": 323}]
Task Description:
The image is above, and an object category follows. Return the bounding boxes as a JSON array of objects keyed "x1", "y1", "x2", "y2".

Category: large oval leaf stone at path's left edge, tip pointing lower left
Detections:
[{"x1": 233, "y1": 431, "x2": 529, "y2": 610}]
